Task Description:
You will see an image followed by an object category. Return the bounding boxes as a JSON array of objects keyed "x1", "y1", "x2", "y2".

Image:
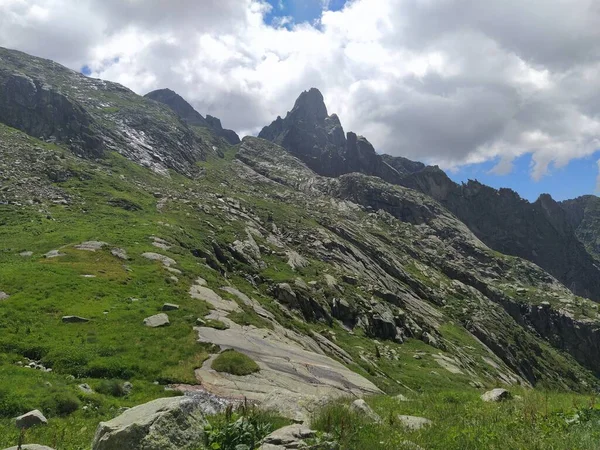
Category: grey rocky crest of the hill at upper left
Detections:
[{"x1": 0, "y1": 48, "x2": 213, "y2": 175}]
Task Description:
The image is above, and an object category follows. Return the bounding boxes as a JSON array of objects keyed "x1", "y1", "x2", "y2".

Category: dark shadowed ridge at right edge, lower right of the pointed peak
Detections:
[{"x1": 401, "y1": 169, "x2": 600, "y2": 300}]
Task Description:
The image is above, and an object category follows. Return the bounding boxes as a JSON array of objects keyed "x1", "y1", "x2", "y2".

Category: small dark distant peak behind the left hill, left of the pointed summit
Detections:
[{"x1": 144, "y1": 89, "x2": 240, "y2": 145}]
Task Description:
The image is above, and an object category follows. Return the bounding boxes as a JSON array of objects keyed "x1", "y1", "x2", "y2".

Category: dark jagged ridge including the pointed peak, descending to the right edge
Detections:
[{"x1": 259, "y1": 89, "x2": 600, "y2": 300}]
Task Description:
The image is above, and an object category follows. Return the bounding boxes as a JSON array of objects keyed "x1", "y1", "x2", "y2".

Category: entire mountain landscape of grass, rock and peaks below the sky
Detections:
[{"x1": 0, "y1": 45, "x2": 600, "y2": 450}]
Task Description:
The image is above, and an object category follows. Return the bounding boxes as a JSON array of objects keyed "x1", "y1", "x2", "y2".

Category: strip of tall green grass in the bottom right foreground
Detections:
[{"x1": 312, "y1": 390, "x2": 600, "y2": 450}]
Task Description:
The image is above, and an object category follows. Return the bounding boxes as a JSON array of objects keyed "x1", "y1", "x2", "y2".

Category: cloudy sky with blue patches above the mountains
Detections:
[{"x1": 0, "y1": 0, "x2": 600, "y2": 200}]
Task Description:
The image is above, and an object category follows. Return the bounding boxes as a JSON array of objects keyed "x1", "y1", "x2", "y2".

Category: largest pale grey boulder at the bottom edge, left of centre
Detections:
[{"x1": 92, "y1": 395, "x2": 224, "y2": 450}]
